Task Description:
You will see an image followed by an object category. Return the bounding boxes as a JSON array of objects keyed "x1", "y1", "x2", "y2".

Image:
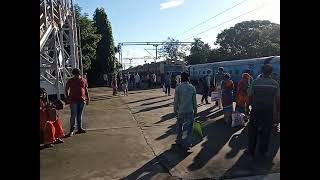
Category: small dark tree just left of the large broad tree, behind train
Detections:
[{"x1": 185, "y1": 38, "x2": 210, "y2": 64}]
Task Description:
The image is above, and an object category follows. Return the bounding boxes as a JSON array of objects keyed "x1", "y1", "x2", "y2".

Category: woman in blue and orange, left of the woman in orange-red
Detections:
[{"x1": 221, "y1": 73, "x2": 234, "y2": 125}]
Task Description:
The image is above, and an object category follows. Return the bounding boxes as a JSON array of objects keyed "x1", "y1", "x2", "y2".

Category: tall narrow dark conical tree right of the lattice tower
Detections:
[{"x1": 92, "y1": 8, "x2": 115, "y2": 85}]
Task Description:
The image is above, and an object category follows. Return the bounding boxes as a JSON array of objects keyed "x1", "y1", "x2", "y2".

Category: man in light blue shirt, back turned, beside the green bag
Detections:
[{"x1": 173, "y1": 72, "x2": 197, "y2": 150}]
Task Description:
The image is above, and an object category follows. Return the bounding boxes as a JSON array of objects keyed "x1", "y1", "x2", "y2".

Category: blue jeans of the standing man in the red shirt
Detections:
[{"x1": 70, "y1": 102, "x2": 84, "y2": 132}]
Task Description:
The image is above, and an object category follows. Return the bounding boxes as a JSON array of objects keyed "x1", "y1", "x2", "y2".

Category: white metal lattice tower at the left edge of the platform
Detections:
[{"x1": 40, "y1": 0, "x2": 79, "y2": 99}]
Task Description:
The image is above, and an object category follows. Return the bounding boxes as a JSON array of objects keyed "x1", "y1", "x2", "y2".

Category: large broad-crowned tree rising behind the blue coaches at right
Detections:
[{"x1": 216, "y1": 20, "x2": 280, "y2": 59}]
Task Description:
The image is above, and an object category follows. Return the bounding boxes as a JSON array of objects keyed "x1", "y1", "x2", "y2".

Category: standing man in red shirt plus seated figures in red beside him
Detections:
[{"x1": 40, "y1": 69, "x2": 90, "y2": 147}]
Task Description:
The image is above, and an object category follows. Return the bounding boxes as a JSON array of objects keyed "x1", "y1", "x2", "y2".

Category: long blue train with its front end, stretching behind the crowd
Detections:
[{"x1": 122, "y1": 56, "x2": 280, "y2": 89}]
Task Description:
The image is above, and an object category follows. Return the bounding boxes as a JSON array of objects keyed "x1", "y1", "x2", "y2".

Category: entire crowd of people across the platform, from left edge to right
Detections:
[{"x1": 40, "y1": 64, "x2": 280, "y2": 159}]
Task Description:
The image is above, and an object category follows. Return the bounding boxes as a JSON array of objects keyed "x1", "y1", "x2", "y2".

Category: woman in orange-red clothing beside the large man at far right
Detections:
[{"x1": 236, "y1": 73, "x2": 251, "y2": 114}]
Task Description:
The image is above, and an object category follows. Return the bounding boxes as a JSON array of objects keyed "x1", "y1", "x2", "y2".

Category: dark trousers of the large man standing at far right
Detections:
[{"x1": 248, "y1": 108, "x2": 273, "y2": 154}]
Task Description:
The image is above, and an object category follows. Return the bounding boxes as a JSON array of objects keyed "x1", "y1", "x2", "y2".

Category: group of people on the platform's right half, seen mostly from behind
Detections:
[{"x1": 172, "y1": 64, "x2": 280, "y2": 157}]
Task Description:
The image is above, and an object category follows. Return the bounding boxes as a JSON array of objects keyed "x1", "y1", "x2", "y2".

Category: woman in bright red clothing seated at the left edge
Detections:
[{"x1": 40, "y1": 88, "x2": 64, "y2": 147}]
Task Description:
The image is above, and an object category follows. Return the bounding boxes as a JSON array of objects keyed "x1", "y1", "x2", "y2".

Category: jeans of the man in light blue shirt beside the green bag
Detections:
[{"x1": 176, "y1": 113, "x2": 194, "y2": 147}]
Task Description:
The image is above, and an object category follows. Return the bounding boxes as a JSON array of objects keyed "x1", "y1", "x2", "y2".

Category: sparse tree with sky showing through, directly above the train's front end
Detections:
[{"x1": 160, "y1": 37, "x2": 186, "y2": 59}]
